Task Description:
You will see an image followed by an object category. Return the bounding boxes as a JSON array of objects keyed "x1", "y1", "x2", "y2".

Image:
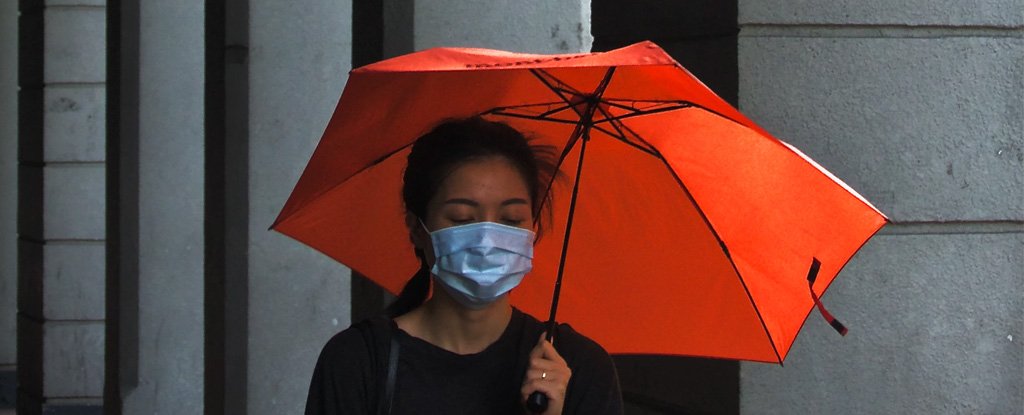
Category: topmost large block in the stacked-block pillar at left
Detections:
[{"x1": 43, "y1": 7, "x2": 106, "y2": 83}]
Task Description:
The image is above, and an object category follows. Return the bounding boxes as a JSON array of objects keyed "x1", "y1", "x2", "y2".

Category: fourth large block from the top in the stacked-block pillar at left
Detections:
[{"x1": 43, "y1": 242, "x2": 106, "y2": 320}]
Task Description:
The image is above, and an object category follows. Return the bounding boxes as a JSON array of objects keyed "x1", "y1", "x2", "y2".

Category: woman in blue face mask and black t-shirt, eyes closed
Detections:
[{"x1": 306, "y1": 117, "x2": 623, "y2": 414}]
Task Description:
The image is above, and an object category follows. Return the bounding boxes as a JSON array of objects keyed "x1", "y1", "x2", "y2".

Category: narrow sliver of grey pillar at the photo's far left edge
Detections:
[{"x1": 0, "y1": 1, "x2": 17, "y2": 408}]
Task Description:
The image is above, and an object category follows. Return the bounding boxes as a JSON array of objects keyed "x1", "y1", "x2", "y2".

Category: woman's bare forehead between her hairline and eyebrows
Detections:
[{"x1": 435, "y1": 157, "x2": 529, "y2": 201}]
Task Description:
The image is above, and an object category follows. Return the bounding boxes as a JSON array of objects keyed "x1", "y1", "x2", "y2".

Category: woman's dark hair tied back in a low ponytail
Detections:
[{"x1": 385, "y1": 116, "x2": 557, "y2": 317}]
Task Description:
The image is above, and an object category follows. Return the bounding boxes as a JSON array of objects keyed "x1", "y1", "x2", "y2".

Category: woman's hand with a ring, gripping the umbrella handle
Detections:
[{"x1": 519, "y1": 333, "x2": 572, "y2": 415}]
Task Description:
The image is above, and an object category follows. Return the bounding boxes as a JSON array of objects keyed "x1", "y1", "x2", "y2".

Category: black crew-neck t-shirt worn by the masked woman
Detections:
[{"x1": 306, "y1": 308, "x2": 623, "y2": 415}]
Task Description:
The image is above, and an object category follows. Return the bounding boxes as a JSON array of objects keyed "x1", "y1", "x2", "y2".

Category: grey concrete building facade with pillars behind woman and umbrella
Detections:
[{"x1": 0, "y1": 0, "x2": 1024, "y2": 414}]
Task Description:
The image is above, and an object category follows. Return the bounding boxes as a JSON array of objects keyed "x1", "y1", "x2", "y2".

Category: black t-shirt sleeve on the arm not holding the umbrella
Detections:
[{"x1": 305, "y1": 328, "x2": 374, "y2": 415}]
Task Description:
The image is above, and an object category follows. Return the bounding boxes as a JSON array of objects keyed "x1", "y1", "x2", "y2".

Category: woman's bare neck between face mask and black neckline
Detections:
[{"x1": 395, "y1": 290, "x2": 512, "y2": 355}]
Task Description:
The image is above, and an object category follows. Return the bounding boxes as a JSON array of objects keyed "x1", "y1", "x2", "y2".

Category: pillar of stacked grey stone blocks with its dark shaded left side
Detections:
[{"x1": 18, "y1": 0, "x2": 106, "y2": 413}]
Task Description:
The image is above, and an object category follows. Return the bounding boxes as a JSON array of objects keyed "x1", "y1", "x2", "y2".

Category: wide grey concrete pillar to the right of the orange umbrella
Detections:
[{"x1": 739, "y1": 0, "x2": 1024, "y2": 414}]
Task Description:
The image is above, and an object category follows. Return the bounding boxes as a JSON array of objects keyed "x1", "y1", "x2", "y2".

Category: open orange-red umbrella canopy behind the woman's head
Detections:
[{"x1": 271, "y1": 42, "x2": 886, "y2": 363}]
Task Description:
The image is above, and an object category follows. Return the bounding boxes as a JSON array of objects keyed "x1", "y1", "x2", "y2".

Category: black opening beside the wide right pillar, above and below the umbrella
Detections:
[{"x1": 591, "y1": 0, "x2": 739, "y2": 414}]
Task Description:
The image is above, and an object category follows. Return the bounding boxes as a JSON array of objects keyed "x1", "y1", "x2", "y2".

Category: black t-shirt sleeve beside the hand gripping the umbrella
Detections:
[{"x1": 563, "y1": 329, "x2": 624, "y2": 415}]
